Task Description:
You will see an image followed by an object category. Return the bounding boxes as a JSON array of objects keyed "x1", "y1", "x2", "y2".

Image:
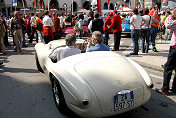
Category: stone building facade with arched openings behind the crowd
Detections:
[{"x1": 0, "y1": 0, "x2": 161, "y2": 16}]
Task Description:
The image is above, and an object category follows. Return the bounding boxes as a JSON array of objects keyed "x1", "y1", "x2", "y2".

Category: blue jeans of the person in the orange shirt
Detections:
[{"x1": 149, "y1": 27, "x2": 157, "y2": 49}]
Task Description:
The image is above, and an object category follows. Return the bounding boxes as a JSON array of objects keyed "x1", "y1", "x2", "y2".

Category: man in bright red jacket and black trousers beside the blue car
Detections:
[{"x1": 109, "y1": 10, "x2": 122, "y2": 51}]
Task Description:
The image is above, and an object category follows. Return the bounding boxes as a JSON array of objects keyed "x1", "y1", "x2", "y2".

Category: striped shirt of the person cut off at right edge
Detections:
[{"x1": 165, "y1": 16, "x2": 176, "y2": 46}]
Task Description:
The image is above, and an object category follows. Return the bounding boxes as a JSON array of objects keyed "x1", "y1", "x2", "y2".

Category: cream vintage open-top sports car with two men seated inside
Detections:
[{"x1": 35, "y1": 39, "x2": 153, "y2": 118}]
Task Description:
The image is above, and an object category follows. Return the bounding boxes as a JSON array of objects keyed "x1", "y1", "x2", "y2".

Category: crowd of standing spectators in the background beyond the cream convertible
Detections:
[{"x1": 0, "y1": 6, "x2": 173, "y2": 55}]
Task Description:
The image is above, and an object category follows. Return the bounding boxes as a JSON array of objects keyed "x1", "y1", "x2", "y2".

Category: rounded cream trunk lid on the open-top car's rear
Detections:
[{"x1": 74, "y1": 55, "x2": 143, "y2": 113}]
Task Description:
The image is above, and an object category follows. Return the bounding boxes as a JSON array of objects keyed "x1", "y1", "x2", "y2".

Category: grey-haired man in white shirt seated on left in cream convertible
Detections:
[{"x1": 49, "y1": 34, "x2": 81, "y2": 62}]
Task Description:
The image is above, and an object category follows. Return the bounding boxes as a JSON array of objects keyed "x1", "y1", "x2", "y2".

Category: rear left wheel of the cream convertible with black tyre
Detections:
[{"x1": 52, "y1": 77, "x2": 67, "y2": 111}]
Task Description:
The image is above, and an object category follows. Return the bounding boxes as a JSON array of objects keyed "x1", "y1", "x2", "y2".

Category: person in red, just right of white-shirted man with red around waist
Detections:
[{"x1": 52, "y1": 12, "x2": 61, "y2": 40}]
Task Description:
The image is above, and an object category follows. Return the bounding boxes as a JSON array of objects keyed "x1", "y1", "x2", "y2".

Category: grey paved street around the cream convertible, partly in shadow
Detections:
[{"x1": 0, "y1": 38, "x2": 176, "y2": 118}]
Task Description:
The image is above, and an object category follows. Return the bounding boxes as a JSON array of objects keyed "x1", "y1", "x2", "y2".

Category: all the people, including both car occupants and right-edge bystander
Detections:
[{"x1": 0, "y1": 6, "x2": 176, "y2": 95}]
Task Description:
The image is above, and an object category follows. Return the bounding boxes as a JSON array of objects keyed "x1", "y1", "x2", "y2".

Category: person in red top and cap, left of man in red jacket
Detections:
[{"x1": 103, "y1": 12, "x2": 113, "y2": 45}]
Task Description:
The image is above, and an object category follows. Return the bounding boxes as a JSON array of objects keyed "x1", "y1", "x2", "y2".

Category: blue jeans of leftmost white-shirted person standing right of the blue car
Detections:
[{"x1": 131, "y1": 29, "x2": 141, "y2": 54}]
